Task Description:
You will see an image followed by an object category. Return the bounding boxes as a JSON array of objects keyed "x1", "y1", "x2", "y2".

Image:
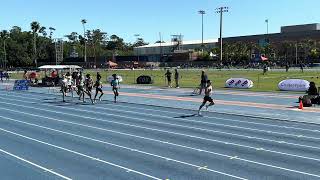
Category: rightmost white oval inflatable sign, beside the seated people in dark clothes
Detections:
[{"x1": 278, "y1": 79, "x2": 310, "y2": 91}]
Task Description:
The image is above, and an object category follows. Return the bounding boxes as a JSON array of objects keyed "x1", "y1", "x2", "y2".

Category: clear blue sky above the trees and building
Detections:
[{"x1": 0, "y1": 0, "x2": 320, "y2": 43}]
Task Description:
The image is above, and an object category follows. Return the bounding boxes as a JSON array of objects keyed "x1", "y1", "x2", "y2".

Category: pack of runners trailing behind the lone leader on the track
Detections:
[{"x1": 61, "y1": 71, "x2": 120, "y2": 104}]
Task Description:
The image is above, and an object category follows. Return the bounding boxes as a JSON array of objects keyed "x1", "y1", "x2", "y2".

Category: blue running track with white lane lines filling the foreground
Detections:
[{"x1": 0, "y1": 91, "x2": 320, "y2": 180}]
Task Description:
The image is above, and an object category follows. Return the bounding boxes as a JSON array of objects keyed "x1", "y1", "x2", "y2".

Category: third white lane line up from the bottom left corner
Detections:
[{"x1": 1, "y1": 116, "x2": 245, "y2": 179}]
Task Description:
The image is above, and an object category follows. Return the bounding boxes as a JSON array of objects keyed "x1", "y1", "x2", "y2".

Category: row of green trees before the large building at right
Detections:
[{"x1": 198, "y1": 39, "x2": 320, "y2": 64}]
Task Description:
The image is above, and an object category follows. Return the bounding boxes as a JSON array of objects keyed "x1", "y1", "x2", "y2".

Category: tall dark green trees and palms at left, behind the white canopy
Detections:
[{"x1": 0, "y1": 21, "x2": 148, "y2": 68}]
